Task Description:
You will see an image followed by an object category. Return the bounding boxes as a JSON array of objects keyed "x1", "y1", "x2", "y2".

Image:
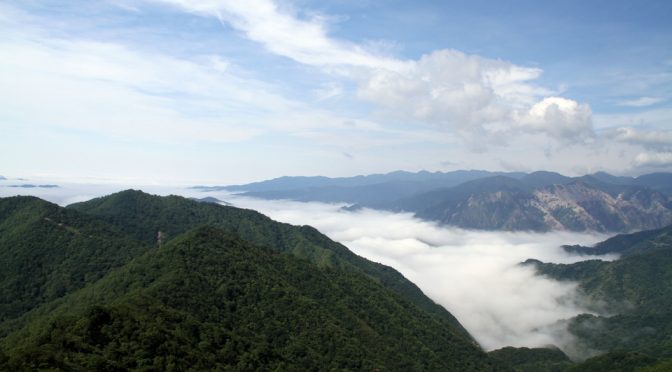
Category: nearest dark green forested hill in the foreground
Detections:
[{"x1": 0, "y1": 227, "x2": 495, "y2": 370}]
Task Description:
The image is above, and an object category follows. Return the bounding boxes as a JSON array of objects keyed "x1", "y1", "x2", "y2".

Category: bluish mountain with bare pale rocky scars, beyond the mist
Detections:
[{"x1": 416, "y1": 181, "x2": 672, "y2": 232}]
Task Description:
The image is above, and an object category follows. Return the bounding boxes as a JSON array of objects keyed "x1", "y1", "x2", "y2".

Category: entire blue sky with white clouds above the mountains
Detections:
[{"x1": 0, "y1": 0, "x2": 672, "y2": 185}]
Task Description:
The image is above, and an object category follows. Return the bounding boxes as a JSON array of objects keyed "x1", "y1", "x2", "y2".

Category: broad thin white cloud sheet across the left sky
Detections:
[{"x1": 0, "y1": 8, "x2": 402, "y2": 147}]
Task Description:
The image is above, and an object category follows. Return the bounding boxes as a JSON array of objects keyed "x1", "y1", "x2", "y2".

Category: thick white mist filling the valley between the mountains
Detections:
[{"x1": 218, "y1": 194, "x2": 615, "y2": 354}]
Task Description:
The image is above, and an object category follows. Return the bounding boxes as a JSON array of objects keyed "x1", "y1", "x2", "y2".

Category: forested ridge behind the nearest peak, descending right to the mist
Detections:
[{"x1": 68, "y1": 190, "x2": 467, "y2": 335}]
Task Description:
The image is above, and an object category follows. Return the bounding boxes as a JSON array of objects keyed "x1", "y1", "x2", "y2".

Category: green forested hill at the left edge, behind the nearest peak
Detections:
[{"x1": 0, "y1": 196, "x2": 147, "y2": 336}]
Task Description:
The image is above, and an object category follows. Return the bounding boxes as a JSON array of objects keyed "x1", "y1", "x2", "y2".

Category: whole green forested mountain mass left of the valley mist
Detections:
[{"x1": 0, "y1": 190, "x2": 498, "y2": 370}]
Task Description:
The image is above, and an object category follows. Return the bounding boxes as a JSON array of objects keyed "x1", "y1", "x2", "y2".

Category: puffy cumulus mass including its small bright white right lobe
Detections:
[{"x1": 359, "y1": 50, "x2": 594, "y2": 143}]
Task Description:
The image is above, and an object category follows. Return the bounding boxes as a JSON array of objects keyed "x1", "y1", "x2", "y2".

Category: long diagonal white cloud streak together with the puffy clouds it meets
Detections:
[{"x1": 151, "y1": 0, "x2": 592, "y2": 147}]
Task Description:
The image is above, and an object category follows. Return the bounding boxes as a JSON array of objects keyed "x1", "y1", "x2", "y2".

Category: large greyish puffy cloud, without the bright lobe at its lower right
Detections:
[{"x1": 359, "y1": 50, "x2": 541, "y2": 132}]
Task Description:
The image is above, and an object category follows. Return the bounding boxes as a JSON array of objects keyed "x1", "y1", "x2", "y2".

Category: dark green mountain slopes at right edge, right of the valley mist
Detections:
[{"x1": 526, "y1": 226, "x2": 672, "y2": 363}]
